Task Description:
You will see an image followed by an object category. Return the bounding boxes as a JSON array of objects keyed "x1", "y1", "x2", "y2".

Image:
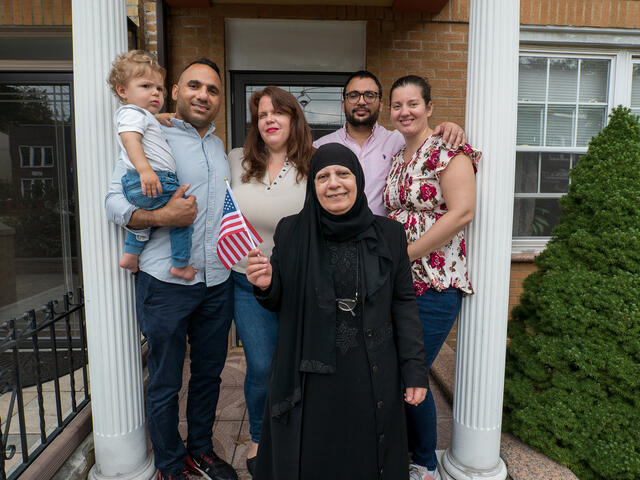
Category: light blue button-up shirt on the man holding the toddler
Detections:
[{"x1": 105, "y1": 118, "x2": 230, "y2": 287}]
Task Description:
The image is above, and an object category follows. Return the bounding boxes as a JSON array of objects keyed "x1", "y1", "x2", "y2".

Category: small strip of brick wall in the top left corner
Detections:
[{"x1": 0, "y1": 0, "x2": 71, "y2": 26}]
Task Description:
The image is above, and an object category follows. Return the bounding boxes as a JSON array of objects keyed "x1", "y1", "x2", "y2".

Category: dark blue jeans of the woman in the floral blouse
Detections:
[{"x1": 405, "y1": 287, "x2": 462, "y2": 470}]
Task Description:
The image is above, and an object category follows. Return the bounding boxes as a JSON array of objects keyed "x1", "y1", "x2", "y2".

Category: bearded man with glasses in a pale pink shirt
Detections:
[{"x1": 313, "y1": 70, "x2": 465, "y2": 215}]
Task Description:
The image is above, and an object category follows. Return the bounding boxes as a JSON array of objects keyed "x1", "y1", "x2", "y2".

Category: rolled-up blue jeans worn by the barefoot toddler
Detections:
[{"x1": 122, "y1": 170, "x2": 193, "y2": 268}]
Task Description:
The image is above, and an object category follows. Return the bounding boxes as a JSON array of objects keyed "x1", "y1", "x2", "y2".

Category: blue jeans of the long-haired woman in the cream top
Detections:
[{"x1": 231, "y1": 272, "x2": 278, "y2": 443}]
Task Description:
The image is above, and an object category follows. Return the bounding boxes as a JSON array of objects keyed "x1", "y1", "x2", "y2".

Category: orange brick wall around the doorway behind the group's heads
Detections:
[{"x1": 167, "y1": 0, "x2": 468, "y2": 152}]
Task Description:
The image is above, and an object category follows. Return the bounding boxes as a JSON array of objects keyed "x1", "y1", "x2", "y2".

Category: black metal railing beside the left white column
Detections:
[{"x1": 0, "y1": 289, "x2": 90, "y2": 480}]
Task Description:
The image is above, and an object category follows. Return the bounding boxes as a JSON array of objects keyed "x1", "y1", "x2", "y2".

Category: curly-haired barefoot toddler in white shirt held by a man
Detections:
[{"x1": 109, "y1": 50, "x2": 197, "y2": 280}]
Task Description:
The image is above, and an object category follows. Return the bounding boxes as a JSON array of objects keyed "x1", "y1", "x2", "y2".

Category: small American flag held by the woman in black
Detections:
[{"x1": 216, "y1": 183, "x2": 262, "y2": 270}]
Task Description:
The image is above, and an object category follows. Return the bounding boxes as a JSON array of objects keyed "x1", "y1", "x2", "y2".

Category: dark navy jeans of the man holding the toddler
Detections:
[{"x1": 136, "y1": 271, "x2": 233, "y2": 474}]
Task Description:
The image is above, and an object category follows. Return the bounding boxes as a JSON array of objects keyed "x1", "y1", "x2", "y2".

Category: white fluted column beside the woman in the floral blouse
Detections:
[{"x1": 442, "y1": 0, "x2": 520, "y2": 480}]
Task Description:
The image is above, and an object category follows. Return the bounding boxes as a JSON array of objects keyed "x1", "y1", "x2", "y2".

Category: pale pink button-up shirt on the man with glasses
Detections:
[{"x1": 313, "y1": 123, "x2": 404, "y2": 216}]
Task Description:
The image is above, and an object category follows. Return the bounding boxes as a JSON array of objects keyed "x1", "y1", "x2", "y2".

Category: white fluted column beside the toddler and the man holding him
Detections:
[{"x1": 72, "y1": 0, "x2": 155, "y2": 480}]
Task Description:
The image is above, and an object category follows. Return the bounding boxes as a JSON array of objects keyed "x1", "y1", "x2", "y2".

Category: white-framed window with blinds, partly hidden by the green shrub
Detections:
[{"x1": 513, "y1": 53, "x2": 613, "y2": 240}]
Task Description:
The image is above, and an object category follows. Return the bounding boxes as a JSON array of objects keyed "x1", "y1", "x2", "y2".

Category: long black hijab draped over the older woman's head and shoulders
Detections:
[{"x1": 270, "y1": 143, "x2": 391, "y2": 421}]
